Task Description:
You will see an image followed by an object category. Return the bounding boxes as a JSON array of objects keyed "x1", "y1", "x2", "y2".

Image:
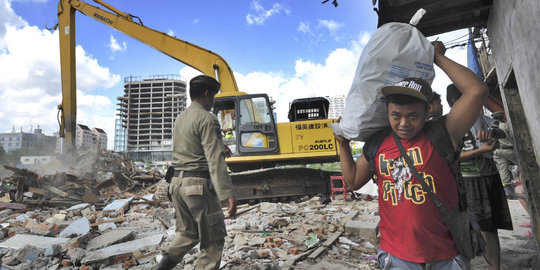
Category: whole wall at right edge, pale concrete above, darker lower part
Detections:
[{"x1": 488, "y1": 0, "x2": 540, "y2": 254}]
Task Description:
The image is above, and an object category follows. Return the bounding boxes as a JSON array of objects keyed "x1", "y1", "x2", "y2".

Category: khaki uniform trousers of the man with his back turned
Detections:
[{"x1": 169, "y1": 175, "x2": 227, "y2": 269}]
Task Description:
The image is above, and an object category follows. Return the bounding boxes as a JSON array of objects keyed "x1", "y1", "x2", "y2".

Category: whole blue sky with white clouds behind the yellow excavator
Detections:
[{"x1": 0, "y1": 0, "x2": 465, "y2": 149}]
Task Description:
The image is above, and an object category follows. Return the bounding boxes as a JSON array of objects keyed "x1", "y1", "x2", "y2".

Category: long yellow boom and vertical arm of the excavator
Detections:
[{"x1": 58, "y1": 0, "x2": 238, "y2": 147}]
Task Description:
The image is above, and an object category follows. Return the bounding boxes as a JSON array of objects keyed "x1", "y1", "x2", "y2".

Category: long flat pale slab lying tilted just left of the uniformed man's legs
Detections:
[{"x1": 81, "y1": 234, "x2": 163, "y2": 264}]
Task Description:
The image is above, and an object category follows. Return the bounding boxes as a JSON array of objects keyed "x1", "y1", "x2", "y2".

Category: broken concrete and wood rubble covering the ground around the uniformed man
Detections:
[{"x1": 0, "y1": 151, "x2": 378, "y2": 269}]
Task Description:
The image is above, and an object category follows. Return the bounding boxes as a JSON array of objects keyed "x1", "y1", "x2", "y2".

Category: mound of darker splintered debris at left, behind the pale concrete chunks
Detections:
[{"x1": 0, "y1": 152, "x2": 163, "y2": 209}]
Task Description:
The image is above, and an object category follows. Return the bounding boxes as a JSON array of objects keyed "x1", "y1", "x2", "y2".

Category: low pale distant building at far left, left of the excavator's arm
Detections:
[{"x1": 0, "y1": 128, "x2": 56, "y2": 153}]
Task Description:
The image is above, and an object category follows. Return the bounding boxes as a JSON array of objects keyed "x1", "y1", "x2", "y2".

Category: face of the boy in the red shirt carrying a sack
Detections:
[{"x1": 388, "y1": 101, "x2": 426, "y2": 140}]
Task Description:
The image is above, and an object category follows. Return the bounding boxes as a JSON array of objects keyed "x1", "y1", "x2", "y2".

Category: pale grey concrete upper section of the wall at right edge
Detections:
[{"x1": 488, "y1": 0, "x2": 540, "y2": 166}]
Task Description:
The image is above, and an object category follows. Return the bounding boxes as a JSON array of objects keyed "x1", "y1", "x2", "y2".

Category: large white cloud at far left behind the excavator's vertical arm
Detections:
[{"x1": 0, "y1": 0, "x2": 120, "y2": 149}]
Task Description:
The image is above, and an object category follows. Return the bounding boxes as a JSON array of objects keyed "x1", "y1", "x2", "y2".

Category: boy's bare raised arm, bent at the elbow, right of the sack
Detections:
[{"x1": 433, "y1": 41, "x2": 488, "y2": 148}]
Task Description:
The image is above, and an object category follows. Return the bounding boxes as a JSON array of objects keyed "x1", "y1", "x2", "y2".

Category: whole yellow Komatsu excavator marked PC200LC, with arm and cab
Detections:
[{"x1": 58, "y1": 0, "x2": 339, "y2": 199}]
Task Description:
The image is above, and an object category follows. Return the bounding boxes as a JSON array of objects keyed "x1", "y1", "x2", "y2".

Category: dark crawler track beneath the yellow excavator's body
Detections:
[{"x1": 231, "y1": 168, "x2": 341, "y2": 201}]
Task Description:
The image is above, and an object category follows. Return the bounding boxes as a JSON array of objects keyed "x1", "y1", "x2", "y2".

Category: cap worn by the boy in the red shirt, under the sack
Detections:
[{"x1": 381, "y1": 78, "x2": 433, "y2": 103}]
